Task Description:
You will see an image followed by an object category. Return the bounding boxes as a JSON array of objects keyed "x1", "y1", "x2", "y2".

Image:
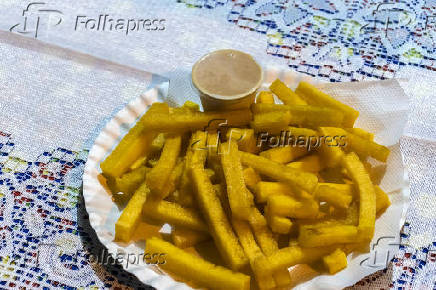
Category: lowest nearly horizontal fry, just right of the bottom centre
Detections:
[{"x1": 254, "y1": 246, "x2": 336, "y2": 273}]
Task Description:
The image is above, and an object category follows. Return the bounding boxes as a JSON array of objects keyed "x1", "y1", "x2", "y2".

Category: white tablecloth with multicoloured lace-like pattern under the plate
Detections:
[{"x1": 0, "y1": 0, "x2": 436, "y2": 289}]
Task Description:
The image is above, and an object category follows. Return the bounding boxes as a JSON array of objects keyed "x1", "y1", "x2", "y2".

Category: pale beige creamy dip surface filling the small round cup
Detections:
[{"x1": 192, "y1": 49, "x2": 262, "y2": 99}]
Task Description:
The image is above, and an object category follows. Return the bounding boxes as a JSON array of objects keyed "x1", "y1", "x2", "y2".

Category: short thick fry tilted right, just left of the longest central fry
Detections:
[{"x1": 145, "y1": 135, "x2": 182, "y2": 198}]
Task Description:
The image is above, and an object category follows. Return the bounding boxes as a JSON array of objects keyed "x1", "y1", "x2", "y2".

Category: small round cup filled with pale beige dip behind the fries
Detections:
[{"x1": 192, "y1": 49, "x2": 263, "y2": 111}]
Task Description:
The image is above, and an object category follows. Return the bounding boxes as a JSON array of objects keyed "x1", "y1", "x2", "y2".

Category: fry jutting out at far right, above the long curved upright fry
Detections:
[{"x1": 324, "y1": 127, "x2": 390, "y2": 162}]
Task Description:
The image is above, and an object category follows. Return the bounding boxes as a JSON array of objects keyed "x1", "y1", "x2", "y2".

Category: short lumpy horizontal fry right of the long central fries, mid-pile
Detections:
[{"x1": 267, "y1": 195, "x2": 319, "y2": 219}]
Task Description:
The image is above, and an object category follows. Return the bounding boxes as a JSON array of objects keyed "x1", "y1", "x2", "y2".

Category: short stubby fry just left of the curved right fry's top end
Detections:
[{"x1": 318, "y1": 127, "x2": 345, "y2": 168}]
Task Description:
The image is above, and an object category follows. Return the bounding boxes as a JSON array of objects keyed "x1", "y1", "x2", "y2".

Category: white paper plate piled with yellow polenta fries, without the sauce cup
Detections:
[{"x1": 83, "y1": 70, "x2": 408, "y2": 289}]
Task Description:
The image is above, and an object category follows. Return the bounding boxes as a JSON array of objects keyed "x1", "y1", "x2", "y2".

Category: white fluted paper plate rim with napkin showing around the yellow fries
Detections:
[{"x1": 83, "y1": 68, "x2": 409, "y2": 289}]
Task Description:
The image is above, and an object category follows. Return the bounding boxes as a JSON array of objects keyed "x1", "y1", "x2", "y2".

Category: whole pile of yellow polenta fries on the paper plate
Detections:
[{"x1": 101, "y1": 76, "x2": 390, "y2": 289}]
